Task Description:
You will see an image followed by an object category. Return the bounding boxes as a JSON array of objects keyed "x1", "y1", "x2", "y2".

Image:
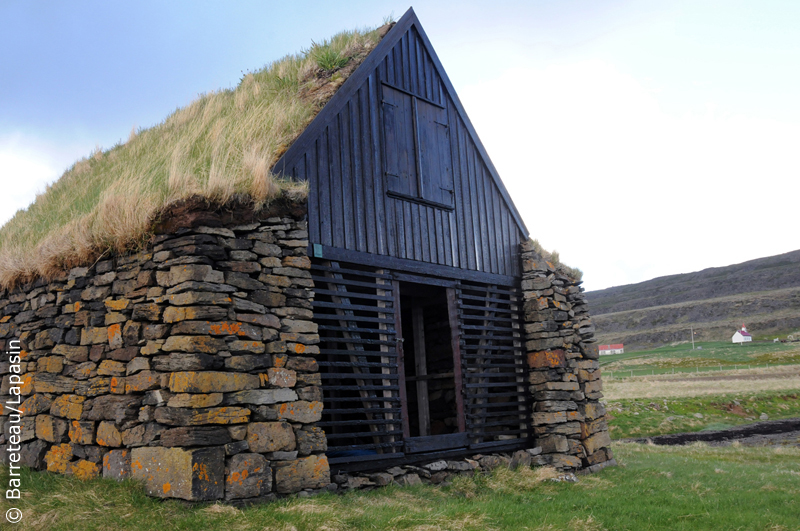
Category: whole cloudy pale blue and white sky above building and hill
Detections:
[{"x1": 0, "y1": 0, "x2": 800, "y2": 290}]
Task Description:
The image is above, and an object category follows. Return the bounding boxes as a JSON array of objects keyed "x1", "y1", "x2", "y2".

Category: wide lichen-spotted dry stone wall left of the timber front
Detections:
[{"x1": 0, "y1": 210, "x2": 331, "y2": 500}]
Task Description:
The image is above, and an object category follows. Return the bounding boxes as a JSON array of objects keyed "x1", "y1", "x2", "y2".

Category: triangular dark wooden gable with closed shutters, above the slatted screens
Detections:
[{"x1": 273, "y1": 9, "x2": 527, "y2": 283}]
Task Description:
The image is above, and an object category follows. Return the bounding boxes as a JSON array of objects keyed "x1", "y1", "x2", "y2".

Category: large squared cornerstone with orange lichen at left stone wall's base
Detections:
[{"x1": 131, "y1": 447, "x2": 225, "y2": 501}]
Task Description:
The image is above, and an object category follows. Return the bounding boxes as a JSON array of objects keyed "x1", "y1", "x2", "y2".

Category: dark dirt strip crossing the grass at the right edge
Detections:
[{"x1": 622, "y1": 418, "x2": 800, "y2": 447}]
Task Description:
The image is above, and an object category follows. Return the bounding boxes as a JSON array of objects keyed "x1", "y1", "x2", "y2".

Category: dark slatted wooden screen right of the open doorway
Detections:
[{"x1": 457, "y1": 282, "x2": 530, "y2": 448}]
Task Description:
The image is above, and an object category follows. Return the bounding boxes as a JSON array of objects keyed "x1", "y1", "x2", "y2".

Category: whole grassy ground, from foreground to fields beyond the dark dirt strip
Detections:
[{"x1": 0, "y1": 344, "x2": 800, "y2": 531}]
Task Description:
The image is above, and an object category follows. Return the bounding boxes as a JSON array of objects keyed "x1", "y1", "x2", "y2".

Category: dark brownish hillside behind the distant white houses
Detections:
[{"x1": 586, "y1": 251, "x2": 800, "y2": 349}]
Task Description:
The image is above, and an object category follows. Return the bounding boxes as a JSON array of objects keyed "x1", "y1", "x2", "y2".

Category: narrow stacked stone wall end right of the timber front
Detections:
[{"x1": 521, "y1": 241, "x2": 615, "y2": 472}]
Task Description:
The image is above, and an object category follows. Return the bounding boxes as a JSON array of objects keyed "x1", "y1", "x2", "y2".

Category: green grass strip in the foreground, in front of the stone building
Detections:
[{"x1": 2, "y1": 444, "x2": 800, "y2": 531}]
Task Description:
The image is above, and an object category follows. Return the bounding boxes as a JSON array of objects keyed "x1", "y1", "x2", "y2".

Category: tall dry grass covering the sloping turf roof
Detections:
[{"x1": 0, "y1": 26, "x2": 388, "y2": 288}]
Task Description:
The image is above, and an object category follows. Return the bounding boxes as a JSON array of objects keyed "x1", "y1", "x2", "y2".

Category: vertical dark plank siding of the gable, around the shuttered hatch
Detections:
[{"x1": 285, "y1": 26, "x2": 523, "y2": 276}]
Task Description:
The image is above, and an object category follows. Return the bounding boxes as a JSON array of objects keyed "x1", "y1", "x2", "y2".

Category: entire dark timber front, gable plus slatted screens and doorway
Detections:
[{"x1": 274, "y1": 10, "x2": 532, "y2": 470}]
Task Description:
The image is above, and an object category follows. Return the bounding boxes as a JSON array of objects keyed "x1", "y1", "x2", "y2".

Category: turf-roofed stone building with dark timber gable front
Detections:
[{"x1": 0, "y1": 10, "x2": 614, "y2": 500}]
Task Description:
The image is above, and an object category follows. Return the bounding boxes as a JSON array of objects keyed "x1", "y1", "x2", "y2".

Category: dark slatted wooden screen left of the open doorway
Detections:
[{"x1": 312, "y1": 259, "x2": 403, "y2": 464}]
